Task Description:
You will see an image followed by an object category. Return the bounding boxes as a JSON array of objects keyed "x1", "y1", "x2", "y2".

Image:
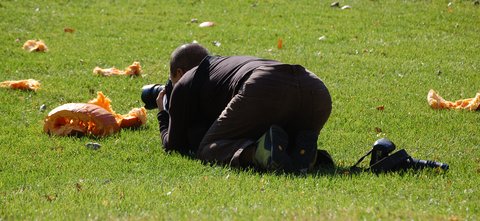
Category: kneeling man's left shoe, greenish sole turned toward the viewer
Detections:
[{"x1": 254, "y1": 125, "x2": 292, "y2": 171}]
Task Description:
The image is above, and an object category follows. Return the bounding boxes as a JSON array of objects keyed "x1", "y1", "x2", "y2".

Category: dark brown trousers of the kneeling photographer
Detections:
[{"x1": 197, "y1": 64, "x2": 332, "y2": 167}]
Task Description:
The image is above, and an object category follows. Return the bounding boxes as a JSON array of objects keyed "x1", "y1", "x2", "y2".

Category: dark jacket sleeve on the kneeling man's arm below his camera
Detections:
[{"x1": 157, "y1": 81, "x2": 189, "y2": 153}]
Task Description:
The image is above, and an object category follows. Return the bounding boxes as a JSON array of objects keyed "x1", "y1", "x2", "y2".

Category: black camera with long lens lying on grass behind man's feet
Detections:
[{"x1": 352, "y1": 138, "x2": 449, "y2": 173}]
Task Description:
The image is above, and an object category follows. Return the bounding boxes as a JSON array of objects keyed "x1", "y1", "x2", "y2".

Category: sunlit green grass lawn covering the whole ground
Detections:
[{"x1": 0, "y1": 0, "x2": 480, "y2": 220}]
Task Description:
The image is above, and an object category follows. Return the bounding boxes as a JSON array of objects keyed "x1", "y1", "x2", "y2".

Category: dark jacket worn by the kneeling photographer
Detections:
[{"x1": 164, "y1": 56, "x2": 280, "y2": 152}]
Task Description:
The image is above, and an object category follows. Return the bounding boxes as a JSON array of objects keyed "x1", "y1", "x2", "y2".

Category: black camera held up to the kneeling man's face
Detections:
[{"x1": 141, "y1": 80, "x2": 173, "y2": 111}]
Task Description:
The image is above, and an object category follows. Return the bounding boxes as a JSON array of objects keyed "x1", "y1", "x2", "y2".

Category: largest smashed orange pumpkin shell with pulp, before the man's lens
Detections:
[{"x1": 43, "y1": 92, "x2": 147, "y2": 136}]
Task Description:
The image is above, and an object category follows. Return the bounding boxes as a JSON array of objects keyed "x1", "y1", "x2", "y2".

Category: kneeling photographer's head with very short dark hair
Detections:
[{"x1": 170, "y1": 43, "x2": 208, "y2": 84}]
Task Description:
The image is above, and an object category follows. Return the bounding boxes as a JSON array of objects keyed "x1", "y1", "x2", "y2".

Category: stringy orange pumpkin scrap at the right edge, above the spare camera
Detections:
[{"x1": 427, "y1": 90, "x2": 480, "y2": 111}]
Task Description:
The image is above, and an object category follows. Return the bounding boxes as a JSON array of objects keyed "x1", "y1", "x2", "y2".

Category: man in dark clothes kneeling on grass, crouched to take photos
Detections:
[{"x1": 157, "y1": 44, "x2": 332, "y2": 171}]
